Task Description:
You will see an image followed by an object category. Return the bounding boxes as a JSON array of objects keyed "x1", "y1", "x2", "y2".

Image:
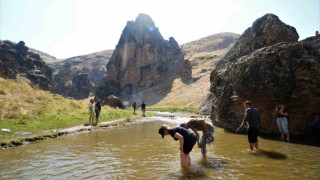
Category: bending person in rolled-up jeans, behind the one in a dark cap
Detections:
[{"x1": 180, "y1": 119, "x2": 214, "y2": 158}]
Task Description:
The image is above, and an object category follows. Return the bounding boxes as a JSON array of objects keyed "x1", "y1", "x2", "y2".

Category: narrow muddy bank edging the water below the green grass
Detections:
[{"x1": 0, "y1": 111, "x2": 156, "y2": 149}]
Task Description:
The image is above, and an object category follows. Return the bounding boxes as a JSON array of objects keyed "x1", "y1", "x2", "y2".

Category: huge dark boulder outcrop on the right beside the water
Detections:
[{"x1": 206, "y1": 14, "x2": 320, "y2": 134}]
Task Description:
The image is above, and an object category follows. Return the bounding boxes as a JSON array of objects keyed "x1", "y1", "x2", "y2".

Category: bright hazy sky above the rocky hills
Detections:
[{"x1": 0, "y1": 0, "x2": 320, "y2": 58}]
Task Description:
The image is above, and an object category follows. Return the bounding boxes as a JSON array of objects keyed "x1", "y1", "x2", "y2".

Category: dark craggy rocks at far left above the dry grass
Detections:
[{"x1": 0, "y1": 41, "x2": 53, "y2": 90}]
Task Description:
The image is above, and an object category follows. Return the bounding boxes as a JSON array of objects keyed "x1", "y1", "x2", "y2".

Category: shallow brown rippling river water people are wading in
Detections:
[{"x1": 0, "y1": 114, "x2": 320, "y2": 179}]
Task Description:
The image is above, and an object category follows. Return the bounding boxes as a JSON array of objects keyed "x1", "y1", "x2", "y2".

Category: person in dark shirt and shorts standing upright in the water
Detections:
[{"x1": 241, "y1": 101, "x2": 261, "y2": 151}]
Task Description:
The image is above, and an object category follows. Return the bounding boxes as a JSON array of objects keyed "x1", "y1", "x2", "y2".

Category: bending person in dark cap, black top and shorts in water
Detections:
[{"x1": 159, "y1": 124, "x2": 197, "y2": 168}]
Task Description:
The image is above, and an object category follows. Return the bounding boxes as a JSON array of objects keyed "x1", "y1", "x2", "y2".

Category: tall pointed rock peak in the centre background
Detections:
[{"x1": 96, "y1": 14, "x2": 191, "y2": 99}]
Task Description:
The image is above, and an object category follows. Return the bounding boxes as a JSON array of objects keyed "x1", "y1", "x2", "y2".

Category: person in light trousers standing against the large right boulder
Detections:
[{"x1": 274, "y1": 104, "x2": 290, "y2": 141}]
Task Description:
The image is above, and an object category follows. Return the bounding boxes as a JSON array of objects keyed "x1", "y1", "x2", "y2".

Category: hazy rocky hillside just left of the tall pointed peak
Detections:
[{"x1": 49, "y1": 50, "x2": 113, "y2": 99}]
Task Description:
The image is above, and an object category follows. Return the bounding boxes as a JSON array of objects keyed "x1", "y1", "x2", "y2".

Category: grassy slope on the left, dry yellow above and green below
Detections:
[{"x1": 0, "y1": 77, "x2": 132, "y2": 142}]
